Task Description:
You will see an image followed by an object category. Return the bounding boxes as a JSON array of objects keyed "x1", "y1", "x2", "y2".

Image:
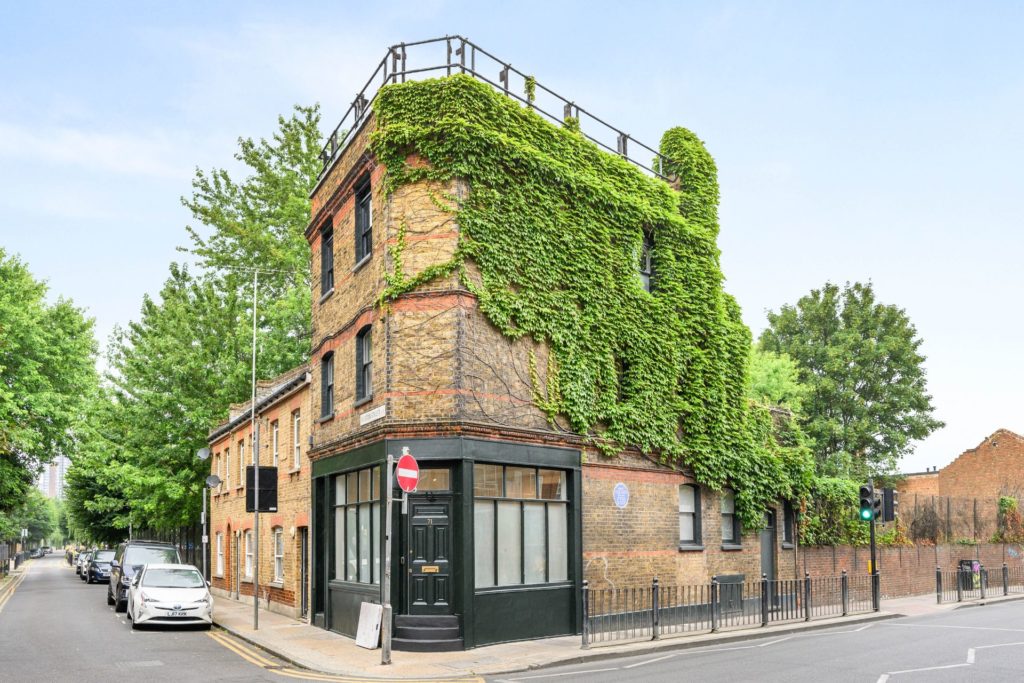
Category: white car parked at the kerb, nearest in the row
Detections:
[{"x1": 128, "y1": 564, "x2": 213, "y2": 629}]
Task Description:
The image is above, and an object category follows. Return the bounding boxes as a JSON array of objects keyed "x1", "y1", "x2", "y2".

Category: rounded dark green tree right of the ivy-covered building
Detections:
[{"x1": 760, "y1": 283, "x2": 942, "y2": 480}]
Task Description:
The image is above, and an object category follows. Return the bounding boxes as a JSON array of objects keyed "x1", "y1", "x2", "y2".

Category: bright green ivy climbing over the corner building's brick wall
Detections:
[{"x1": 372, "y1": 76, "x2": 810, "y2": 526}]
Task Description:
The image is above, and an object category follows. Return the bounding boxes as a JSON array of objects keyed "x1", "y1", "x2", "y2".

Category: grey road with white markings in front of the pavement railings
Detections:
[{"x1": 487, "y1": 601, "x2": 1024, "y2": 683}]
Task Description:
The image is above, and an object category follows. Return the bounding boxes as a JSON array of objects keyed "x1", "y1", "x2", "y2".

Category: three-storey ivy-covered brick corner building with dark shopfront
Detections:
[{"x1": 306, "y1": 38, "x2": 796, "y2": 649}]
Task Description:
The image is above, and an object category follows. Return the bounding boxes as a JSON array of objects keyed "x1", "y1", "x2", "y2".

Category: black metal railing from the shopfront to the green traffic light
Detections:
[{"x1": 583, "y1": 571, "x2": 880, "y2": 648}]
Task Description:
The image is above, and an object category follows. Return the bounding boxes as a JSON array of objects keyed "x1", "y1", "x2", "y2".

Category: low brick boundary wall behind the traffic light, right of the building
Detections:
[{"x1": 799, "y1": 543, "x2": 1024, "y2": 598}]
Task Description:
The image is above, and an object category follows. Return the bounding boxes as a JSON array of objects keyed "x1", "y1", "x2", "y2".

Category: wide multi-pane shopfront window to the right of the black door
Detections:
[{"x1": 473, "y1": 464, "x2": 568, "y2": 588}]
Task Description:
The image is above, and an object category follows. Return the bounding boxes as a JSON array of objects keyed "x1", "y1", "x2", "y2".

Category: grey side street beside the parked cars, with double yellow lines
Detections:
[{"x1": 0, "y1": 553, "x2": 294, "y2": 683}]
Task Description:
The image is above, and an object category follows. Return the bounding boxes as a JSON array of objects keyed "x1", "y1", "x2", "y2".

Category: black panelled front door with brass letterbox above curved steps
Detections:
[{"x1": 406, "y1": 495, "x2": 452, "y2": 614}]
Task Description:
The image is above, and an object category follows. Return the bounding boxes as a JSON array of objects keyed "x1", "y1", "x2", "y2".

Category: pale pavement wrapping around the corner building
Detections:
[{"x1": 207, "y1": 593, "x2": 1024, "y2": 680}]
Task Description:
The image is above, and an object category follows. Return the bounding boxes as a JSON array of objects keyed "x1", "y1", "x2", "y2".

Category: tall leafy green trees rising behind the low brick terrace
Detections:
[{"x1": 68, "y1": 108, "x2": 319, "y2": 542}]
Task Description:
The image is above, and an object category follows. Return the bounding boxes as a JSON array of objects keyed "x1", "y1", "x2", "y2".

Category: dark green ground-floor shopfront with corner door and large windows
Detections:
[{"x1": 311, "y1": 437, "x2": 583, "y2": 649}]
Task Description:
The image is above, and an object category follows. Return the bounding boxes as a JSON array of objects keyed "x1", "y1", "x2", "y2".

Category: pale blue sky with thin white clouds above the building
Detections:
[{"x1": 0, "y1": 0, "x2": 1024, "y2": 471}]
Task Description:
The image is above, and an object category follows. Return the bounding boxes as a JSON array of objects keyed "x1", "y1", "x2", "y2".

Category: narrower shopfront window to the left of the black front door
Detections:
[{"x1": 334, "y1": 467, "x2": 381, "y2": 584}]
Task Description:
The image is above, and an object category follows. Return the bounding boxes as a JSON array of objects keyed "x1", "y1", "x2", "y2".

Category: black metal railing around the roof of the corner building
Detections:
[{"x1": 319, "y1": 36, "x2": 668, "y2": 184}]
